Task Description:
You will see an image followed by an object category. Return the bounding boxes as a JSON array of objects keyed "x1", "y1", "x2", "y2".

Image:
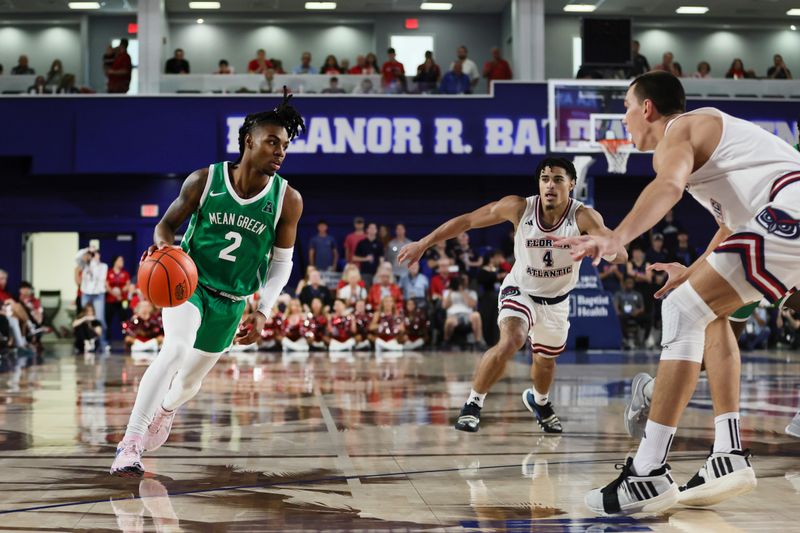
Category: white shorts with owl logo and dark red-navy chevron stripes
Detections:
[{"x1": 708, "y1": 178, "x2": 800, "y2": 304}]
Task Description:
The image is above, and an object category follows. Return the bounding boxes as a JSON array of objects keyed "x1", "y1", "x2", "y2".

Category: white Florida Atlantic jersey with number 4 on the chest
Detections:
[{"x1": 510, "y1": 195, "x2": 583, "y2": 298}]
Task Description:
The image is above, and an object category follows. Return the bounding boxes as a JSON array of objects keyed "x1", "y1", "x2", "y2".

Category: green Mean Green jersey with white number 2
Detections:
[{"x1": 181, "y1": 162, "x2": 286, "y2": 296}]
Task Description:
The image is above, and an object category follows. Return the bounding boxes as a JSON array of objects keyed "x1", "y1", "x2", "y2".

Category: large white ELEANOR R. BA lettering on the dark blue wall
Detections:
[{"x1": 226, "y1": 116, "x2": 547, "y2": 155}]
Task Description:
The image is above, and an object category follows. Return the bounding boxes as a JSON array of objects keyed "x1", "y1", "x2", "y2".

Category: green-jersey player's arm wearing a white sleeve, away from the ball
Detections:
[{"x1": 239, "y1": 185, "x2": 303, "y2": 345}]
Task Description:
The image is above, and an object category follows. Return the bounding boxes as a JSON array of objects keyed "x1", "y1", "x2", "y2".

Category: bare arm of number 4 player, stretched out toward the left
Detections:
[{"x1": 397, "y1": 196, "x2": 526, "y2": 264}]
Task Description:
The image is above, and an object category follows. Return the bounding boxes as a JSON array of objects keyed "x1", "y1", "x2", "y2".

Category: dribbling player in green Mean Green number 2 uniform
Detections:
[{"x1": 111, "y1": 89, "x2": 305, "y2": 476}]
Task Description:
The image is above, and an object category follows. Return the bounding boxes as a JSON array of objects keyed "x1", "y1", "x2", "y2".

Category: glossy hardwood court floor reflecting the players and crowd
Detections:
[{"x1": 0, "y1": 342, "x2": 800, "y2": 532}]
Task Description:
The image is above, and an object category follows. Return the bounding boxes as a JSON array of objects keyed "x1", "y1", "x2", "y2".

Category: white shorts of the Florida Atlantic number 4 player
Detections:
[{"x1": 497, "y1": 277, "x2": 569, "y2": 357}]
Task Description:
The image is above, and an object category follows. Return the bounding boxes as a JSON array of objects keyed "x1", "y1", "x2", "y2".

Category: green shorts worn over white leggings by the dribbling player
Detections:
[{"x1": 189, "y1": 285, "x2": 247, "y2": 353}]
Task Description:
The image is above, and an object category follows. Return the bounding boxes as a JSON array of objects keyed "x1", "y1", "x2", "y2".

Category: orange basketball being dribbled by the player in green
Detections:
[{"x1": 138, "y1": 246, "x2": 197, "y2": 307}]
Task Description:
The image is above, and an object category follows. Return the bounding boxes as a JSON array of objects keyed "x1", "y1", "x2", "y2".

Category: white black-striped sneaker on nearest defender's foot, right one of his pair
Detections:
[{"x1": 678, "y1": 450, "x2": 758, "y2": 507}]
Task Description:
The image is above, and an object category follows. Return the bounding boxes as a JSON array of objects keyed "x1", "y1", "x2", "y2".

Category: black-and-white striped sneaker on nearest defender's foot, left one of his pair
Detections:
[{"x1": 584, "y1": 458, "x2": 679, "y2": 516}]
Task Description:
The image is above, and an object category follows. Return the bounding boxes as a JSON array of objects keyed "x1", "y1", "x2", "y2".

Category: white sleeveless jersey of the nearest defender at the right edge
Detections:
[{"x1": 666, "y1": 107, "x2": 800, "y2": 229}]
